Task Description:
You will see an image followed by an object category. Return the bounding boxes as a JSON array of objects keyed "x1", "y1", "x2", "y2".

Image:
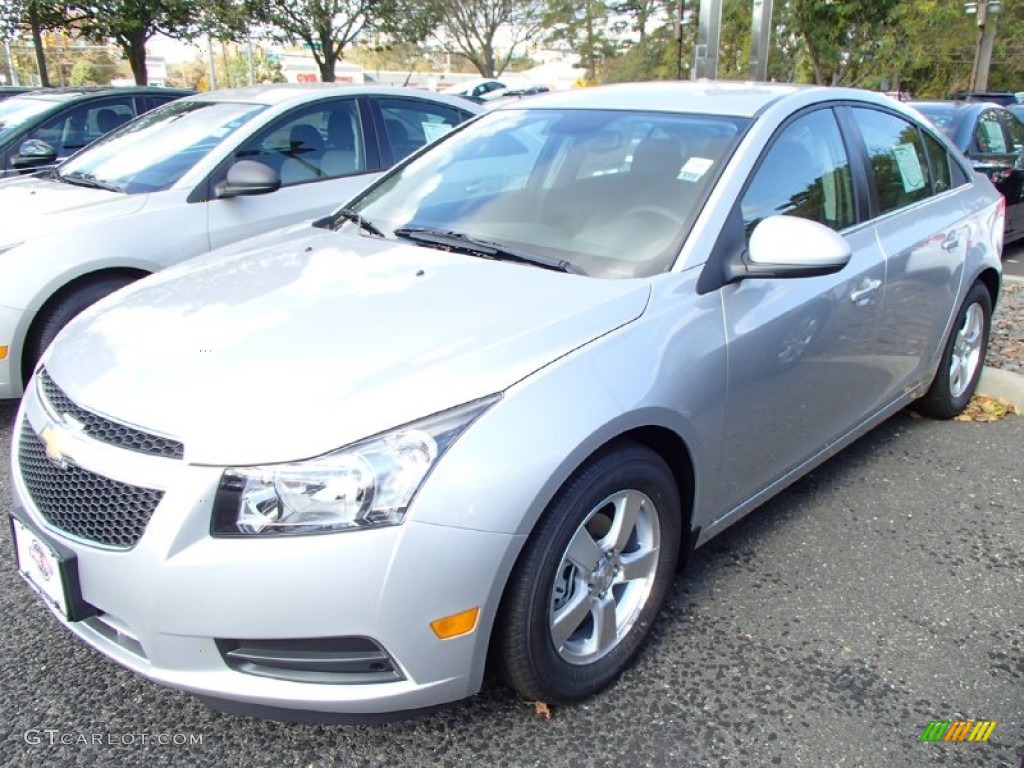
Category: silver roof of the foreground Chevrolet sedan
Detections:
[{"x1": 487, "y1": 81, "x2": 896, "y2": 118}]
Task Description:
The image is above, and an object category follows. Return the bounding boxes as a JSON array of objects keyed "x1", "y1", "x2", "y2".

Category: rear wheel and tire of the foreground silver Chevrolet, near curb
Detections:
[{"x1": 914, "y1": 283, "x2": 992, "y2": 419}]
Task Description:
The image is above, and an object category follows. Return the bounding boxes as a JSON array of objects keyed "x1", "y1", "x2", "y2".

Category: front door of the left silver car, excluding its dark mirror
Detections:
[{"x1": 205, "y1": 96, "x2": 381, "y2": 248}]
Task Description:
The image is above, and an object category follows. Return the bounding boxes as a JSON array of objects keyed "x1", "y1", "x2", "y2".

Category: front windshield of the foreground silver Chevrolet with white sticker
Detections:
[{"x1": 346, "y1": 109, "x2": 749, "y2": 278}]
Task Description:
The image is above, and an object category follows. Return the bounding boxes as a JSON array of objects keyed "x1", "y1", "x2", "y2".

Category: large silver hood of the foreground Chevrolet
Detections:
[{"x1": 46, "y1": 229, "x2": 649, "y2": 465}]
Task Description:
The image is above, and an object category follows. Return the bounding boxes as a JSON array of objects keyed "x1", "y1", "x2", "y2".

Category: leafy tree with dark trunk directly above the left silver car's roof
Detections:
[{"x1": 248, "y1": 0, "x2": 437, "y2": 83}]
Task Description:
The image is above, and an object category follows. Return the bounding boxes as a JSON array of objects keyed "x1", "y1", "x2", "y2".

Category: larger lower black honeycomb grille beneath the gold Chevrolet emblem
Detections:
[{"x1": 17, "y1": 421, "x2": 164, "y2": 549}]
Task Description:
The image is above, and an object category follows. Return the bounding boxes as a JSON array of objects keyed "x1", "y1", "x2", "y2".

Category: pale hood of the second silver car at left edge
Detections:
[{"x1": 0, "y1": 176, "x2": 146, "y2": 248}]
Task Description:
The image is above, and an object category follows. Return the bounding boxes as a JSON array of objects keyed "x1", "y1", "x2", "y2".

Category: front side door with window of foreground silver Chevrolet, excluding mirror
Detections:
[{"x1": 720, "y1": 109, "x2": 891, "y2": 518}]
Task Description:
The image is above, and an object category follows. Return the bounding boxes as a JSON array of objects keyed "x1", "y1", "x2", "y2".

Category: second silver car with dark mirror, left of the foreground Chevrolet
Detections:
[{"x1": 0, "y1": 84, "x2": 479, "y2": 397}]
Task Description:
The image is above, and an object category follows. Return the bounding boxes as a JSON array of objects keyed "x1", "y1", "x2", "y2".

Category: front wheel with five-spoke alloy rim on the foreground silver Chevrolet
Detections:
[{"x1": 496, "y1": 442, "x2": 682, "y2": 703}]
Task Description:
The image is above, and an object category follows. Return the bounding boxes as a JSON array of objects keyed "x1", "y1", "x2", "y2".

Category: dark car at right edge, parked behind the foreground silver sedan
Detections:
[{"x1": 911, "y1": 101, "x2": 1024, "y2": 243}]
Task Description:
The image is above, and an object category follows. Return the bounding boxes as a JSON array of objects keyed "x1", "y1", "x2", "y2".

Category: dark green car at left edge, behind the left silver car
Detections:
[{"x1": 0, "y1": 87, "x2": 193, "y2": 178}]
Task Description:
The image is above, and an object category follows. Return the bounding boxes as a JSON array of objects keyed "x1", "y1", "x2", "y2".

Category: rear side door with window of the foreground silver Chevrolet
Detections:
[{"x1": 849, "y1": 106, "x2": 970, "y2": 390}]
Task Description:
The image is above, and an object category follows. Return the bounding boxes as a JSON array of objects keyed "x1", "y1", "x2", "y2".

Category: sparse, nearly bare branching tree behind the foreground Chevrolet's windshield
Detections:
[{"x1": 434, "y1": 0, "x2": 544, "y2": 78}]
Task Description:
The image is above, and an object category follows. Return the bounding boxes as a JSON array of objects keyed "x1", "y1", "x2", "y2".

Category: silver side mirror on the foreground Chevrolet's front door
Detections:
[{"x1": 726, "y1": 216, "x2": 853, "y2": 283}]
